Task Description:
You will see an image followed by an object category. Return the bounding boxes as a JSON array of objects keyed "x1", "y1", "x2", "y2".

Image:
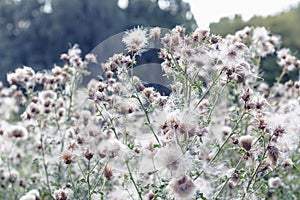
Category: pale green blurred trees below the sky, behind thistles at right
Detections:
[{"x1": 210, "y1": 3, "x2": 300, "y2": 85}]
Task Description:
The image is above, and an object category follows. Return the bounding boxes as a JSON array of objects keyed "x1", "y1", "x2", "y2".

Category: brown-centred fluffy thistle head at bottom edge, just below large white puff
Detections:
[{"x1": 169, "y1": 175, "x2": 196, "y2": 199}]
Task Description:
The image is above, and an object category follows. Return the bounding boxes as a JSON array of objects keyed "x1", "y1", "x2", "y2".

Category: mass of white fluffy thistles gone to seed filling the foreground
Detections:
[{"x1": 0, "y1": 26, "x2": 300, "y2": 200}]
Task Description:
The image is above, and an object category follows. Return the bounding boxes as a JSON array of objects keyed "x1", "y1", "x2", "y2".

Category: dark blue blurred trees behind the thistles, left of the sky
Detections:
[{"x1": 0, "y1": 0, "x2": 196, "y2": 81}]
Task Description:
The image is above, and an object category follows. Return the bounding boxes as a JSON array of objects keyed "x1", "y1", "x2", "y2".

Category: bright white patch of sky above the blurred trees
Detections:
[{"x1": 184, "y1": 0, "x2": 300, "y2": 28}]
